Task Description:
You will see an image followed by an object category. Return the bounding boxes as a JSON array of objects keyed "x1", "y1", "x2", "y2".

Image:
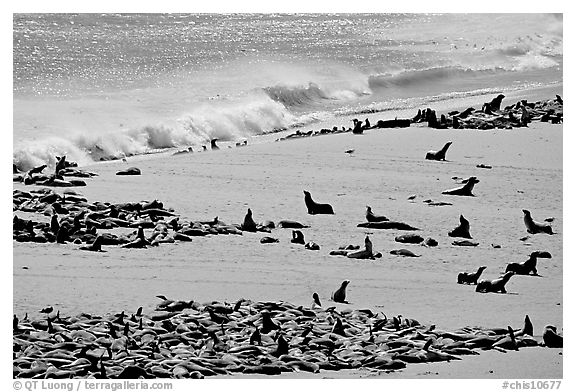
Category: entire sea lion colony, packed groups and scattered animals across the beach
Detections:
[{"x1": 13, "y1": 94, "x2": 562, "y2": 378}]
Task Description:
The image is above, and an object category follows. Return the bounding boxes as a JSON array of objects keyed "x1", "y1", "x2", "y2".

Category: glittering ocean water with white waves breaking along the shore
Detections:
[{"x1": 13, "y1": 14, "x2": 563, "y2": 170}]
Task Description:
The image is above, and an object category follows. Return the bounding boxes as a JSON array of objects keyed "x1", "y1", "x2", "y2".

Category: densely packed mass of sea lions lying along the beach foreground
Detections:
[{"x1": 13, "y1": 294, "x2": 563, "y2": 379}]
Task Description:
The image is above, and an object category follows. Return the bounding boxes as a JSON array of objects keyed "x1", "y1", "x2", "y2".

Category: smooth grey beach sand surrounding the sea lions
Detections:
[{"x1": 13, "y1": 86, "x2": 564, "y2": 378}]
